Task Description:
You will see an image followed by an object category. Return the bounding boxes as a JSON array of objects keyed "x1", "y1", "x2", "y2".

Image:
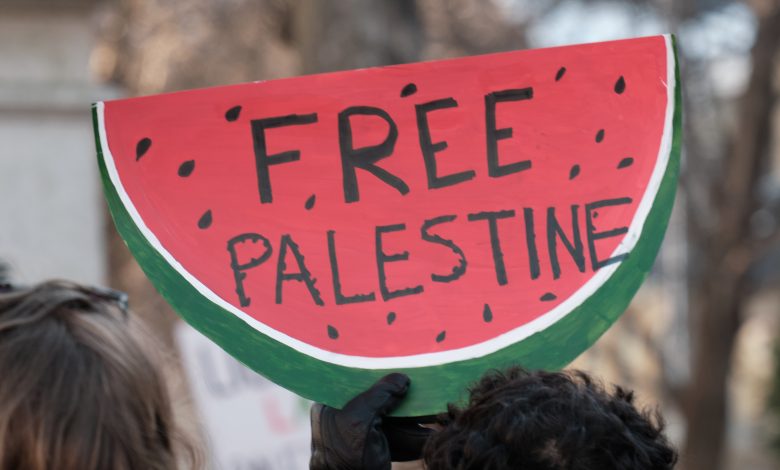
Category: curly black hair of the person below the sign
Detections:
[{"x1": 423, "y1": 368, "x2": 677, "y2": 470}]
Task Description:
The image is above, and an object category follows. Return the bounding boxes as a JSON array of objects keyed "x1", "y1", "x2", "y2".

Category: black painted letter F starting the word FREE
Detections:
[{"x1": 251, "y1": 113, "x2": 317, "y2": 204}]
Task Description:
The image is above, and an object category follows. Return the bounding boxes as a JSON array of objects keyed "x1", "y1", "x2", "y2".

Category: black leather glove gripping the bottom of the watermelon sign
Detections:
[{"x1": 309, "y1": 374, "x2": 430, "y2": 470}]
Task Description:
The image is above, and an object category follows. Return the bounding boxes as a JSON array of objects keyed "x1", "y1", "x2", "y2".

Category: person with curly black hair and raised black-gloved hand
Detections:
[{"x1": 310, "y1": 368, "x2": 677, "y2": 470}]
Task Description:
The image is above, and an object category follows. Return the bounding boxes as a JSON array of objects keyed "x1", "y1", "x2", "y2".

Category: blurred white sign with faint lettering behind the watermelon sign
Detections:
[{"x1": 176, "y1": 323, "x2": 311, "y2": 470}]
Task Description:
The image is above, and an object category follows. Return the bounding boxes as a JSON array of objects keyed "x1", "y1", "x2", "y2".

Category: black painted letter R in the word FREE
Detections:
[{"x1": 338, "y1": 106, "x2": 409, "y2": 203}]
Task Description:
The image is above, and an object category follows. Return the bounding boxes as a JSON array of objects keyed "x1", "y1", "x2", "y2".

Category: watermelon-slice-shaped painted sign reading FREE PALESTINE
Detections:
[{"x1": 94, "y1": 36, "x2": 680, "y2": 415}]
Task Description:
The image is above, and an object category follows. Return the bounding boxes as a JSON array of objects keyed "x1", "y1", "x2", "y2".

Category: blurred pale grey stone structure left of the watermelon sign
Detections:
[{"x1": 0, "y1": 0, "x2": 115, "y2": 283}]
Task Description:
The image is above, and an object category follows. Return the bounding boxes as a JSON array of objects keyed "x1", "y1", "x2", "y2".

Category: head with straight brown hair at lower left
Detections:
[{"x1": 0, "y1": 281, "x2": 193, "y2": 470}]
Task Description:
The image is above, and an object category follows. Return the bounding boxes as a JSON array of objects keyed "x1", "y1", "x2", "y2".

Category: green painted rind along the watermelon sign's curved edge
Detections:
[{"x1": 93, "y1": 46, "x2": 682, "y2": 416}]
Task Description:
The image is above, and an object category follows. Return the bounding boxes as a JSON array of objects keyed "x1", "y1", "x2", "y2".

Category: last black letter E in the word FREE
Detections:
[{"x1": 485, "y1": 87, "x2": 534, "y2": 178}]
